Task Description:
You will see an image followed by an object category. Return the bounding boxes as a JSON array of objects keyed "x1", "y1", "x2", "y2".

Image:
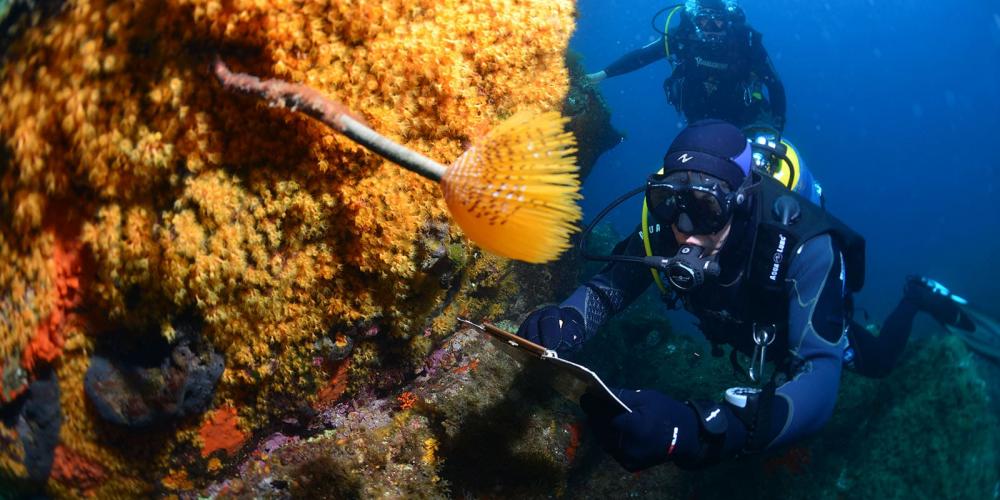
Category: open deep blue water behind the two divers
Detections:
[{"x1": 571, "y1": 0, "x2": 1000, "y2": 324}]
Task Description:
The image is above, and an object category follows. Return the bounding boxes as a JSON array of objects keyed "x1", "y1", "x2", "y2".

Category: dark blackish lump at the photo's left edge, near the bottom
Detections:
[{"x1": 2, "y1": 372, "x2": 62, "y2": 483}]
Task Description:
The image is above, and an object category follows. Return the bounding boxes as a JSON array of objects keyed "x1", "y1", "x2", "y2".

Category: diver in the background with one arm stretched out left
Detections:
[{"x1": 587, "y1": 0, "x2": 785, "y2": 133}]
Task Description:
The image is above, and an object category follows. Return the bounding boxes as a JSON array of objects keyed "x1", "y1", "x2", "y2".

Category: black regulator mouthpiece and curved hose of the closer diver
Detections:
[{"x1": 579, "y1": 186, "x2": 720, "y2": 292}]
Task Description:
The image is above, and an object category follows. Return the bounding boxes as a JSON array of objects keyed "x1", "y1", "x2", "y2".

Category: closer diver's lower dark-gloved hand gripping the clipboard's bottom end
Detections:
[{"x1": 580, "y1": 389, "x2": 701, "y2": 472}]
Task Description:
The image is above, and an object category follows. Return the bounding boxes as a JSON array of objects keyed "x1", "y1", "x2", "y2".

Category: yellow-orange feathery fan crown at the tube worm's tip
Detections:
[{"x1": 441, "y1": 112, "x2": 582, "y2": 263}]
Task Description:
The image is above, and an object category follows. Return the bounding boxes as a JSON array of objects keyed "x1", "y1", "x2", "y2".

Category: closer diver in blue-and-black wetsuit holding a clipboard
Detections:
[{"x1": 517, "y1": 120, "x2": 965, "y2": 471}]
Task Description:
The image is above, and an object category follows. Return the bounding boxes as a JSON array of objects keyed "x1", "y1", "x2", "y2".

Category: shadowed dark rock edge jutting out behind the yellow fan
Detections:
[{"x1": 562, "y1": 51, "x2": 624, "y2": 182}]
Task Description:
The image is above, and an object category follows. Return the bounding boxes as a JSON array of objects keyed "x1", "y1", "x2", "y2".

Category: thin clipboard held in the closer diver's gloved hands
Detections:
[{"x1": 458, "y1": 317, "x2": 632, "y2": 413}]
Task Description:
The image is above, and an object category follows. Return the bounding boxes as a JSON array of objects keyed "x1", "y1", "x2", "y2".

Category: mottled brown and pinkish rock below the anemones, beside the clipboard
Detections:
[{"x1": 200, "y1": 329, "x2": 589, "y2": 498}]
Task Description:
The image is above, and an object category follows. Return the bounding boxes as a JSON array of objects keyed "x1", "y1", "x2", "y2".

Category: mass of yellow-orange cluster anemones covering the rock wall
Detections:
[{"x1": 0, "y1": 0, "x2": 575, "y2": 497}]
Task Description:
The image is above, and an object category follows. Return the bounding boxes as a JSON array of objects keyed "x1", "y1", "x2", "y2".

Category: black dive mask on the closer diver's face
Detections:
[{"x1": 646, "y1": 173, "x2": 732, "y2": 235}]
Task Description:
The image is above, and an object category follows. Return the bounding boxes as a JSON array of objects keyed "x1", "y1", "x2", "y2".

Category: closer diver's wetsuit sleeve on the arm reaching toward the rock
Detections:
[{"x1": 560, "y1": 229, "x2": 653, "y2": 341}]
